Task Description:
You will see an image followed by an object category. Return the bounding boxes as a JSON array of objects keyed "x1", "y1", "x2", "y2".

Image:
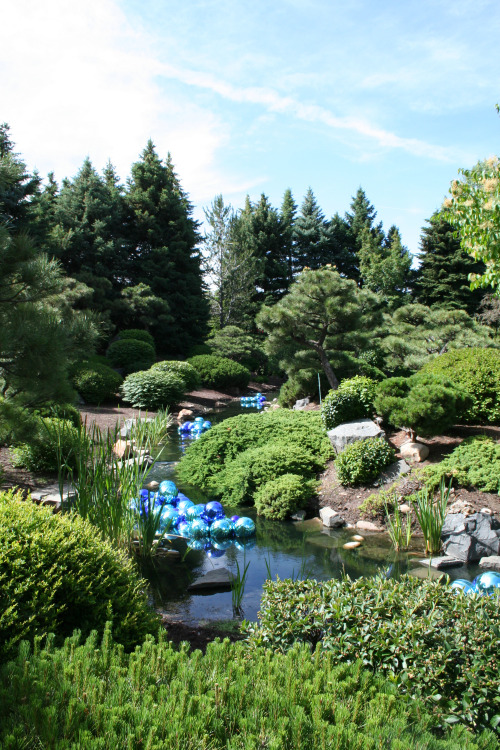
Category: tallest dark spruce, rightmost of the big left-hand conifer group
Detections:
[{"x1": 126, "y1": 141, "x2": 209, "y2": 355}]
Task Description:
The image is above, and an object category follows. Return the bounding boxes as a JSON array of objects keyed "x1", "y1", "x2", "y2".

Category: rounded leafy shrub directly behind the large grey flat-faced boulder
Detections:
[{"x1": 321, "y1": 375, "x2": 376, "y2": 430}]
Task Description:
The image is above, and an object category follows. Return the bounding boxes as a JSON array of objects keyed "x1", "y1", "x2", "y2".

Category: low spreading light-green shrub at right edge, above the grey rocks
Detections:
[{"x1": 424, "y1": 436, "x2": 500, "y2": 495}]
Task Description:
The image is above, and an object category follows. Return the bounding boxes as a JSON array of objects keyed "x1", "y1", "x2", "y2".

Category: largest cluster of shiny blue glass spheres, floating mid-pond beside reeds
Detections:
[{"x1": 136, "y1": 480, "x2": 255, "y2": 557}]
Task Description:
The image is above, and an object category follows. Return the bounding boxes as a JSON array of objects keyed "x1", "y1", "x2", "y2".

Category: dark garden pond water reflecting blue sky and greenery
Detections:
[{"x1": 142, "y1": 403, "x2": 476, "y2": 623}]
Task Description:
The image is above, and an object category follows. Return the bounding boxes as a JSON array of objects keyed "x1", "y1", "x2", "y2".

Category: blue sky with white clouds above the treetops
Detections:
[{"x1": 0, "y1": 0, "x2": 500, "y2": 254}]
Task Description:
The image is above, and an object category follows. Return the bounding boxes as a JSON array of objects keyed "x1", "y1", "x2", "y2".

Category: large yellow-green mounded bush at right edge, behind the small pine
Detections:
[{"x1": 423, "y1": 348, "x2": 500, "y2": 424}]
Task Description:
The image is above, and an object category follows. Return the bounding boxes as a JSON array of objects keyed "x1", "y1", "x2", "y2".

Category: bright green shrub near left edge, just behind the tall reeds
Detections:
[{"x1": 11, "y1": 417, "x2": 78, "y2": 472}]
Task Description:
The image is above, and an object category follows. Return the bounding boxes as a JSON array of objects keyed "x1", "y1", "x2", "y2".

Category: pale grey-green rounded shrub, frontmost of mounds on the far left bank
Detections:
[{"x1": 121, "y1": 369, "x2": 186, "y2": 411}]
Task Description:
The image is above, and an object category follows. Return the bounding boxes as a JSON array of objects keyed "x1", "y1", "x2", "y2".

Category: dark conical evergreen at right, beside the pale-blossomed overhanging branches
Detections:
[{"x1": 413, "y1": 210, "x2": 485, "y2": 315}]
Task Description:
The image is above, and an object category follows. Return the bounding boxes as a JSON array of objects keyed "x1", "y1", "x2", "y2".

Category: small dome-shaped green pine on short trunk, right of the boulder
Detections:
[{"x1": 375, "y1": 373, "x2": 470, "y2": 437}]
